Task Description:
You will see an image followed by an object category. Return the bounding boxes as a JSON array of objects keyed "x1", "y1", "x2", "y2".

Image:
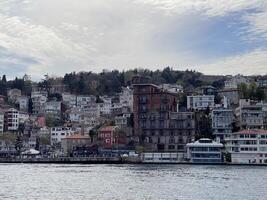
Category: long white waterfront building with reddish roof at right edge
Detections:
[{"x1": 225, "y1": 130, "x2": 267, "y2": 163}]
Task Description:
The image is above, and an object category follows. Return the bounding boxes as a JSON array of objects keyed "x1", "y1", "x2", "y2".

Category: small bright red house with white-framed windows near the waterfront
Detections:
[{"x1": 98, "y1": 126, "x2": 118, "y2": 149}]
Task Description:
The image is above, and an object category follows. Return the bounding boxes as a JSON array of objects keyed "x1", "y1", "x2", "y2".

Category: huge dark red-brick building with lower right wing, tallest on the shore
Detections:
[{"x1": 133, "y1": 76, "x2": 195, "y2": 151}]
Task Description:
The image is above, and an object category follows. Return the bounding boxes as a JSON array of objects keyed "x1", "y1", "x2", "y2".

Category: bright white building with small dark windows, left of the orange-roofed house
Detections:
[{"x1": 51, "y1": 127, "x2": 76, "y2": 145}]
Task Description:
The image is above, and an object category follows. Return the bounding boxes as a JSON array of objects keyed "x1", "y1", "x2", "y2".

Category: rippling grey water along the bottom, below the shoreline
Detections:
[{"x1": 0, "y1": 164, "x2": 267, "y2": 200}]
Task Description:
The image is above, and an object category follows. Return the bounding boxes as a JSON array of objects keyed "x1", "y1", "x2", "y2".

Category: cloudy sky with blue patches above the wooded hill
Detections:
[{"x1": 0, "y1": 0, "x2": 267, "y2": 79}]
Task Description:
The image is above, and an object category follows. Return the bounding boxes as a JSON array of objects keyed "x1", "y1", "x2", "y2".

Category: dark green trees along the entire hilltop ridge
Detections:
[{"x1": 0, "y1": 67, "x2": 266, "y2": 98}]
